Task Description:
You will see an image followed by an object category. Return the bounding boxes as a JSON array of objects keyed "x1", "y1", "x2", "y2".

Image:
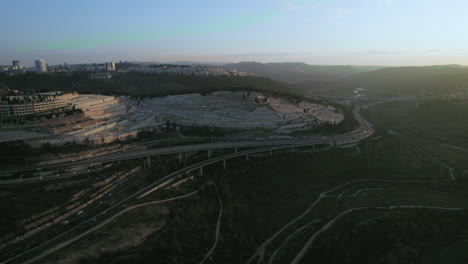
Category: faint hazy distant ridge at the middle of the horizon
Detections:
[{"x1": 224, "y1": 62, "x2": 381, "y2": 83}]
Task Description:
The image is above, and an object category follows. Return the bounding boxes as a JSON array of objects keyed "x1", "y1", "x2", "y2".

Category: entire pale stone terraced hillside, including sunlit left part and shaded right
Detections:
[{"x1": 0, "y1": 92, "x2": 344, "y2": 144}]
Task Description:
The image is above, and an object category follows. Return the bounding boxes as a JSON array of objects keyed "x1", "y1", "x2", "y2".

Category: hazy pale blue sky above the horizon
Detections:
[{"x1": 0, "y1": 0, "x2": 468, "y2": 66}]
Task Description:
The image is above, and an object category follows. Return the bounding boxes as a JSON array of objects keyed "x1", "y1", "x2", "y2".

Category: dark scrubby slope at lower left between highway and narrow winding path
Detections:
[{"x1": 49, "y1": 186, "x2": 219, "y2": 264}]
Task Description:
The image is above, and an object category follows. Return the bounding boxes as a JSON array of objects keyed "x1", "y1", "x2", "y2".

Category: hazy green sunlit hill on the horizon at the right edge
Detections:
[{"x1": 329, "y1": 65, "x2": 468, "y2": 96}]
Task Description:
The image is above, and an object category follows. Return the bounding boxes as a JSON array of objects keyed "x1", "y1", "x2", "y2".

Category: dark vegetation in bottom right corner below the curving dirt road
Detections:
[{"x1": 303, "y1": 209, "x2": 468, "y2": 264}]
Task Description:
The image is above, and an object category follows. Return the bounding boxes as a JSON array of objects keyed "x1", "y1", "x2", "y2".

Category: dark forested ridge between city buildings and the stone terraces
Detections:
[{"x1": 0, "y1": 73, "x2": 302, "y2": 96}]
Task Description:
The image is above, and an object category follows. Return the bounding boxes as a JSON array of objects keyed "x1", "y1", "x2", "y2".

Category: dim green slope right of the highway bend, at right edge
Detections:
[{"x1": 364, "y1": 100, "x2": 468, "y2": 175}]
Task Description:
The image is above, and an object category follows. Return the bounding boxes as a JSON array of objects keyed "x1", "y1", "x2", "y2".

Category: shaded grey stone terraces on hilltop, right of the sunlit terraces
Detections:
[{"x1": 129, "y1": 92, "x2": 343, "y2": 132}]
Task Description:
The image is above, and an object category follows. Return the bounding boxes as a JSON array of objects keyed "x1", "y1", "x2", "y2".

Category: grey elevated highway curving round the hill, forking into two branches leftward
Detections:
[{"x1": 0, "y1": 102, "x2": 374, "y2": 263}]
